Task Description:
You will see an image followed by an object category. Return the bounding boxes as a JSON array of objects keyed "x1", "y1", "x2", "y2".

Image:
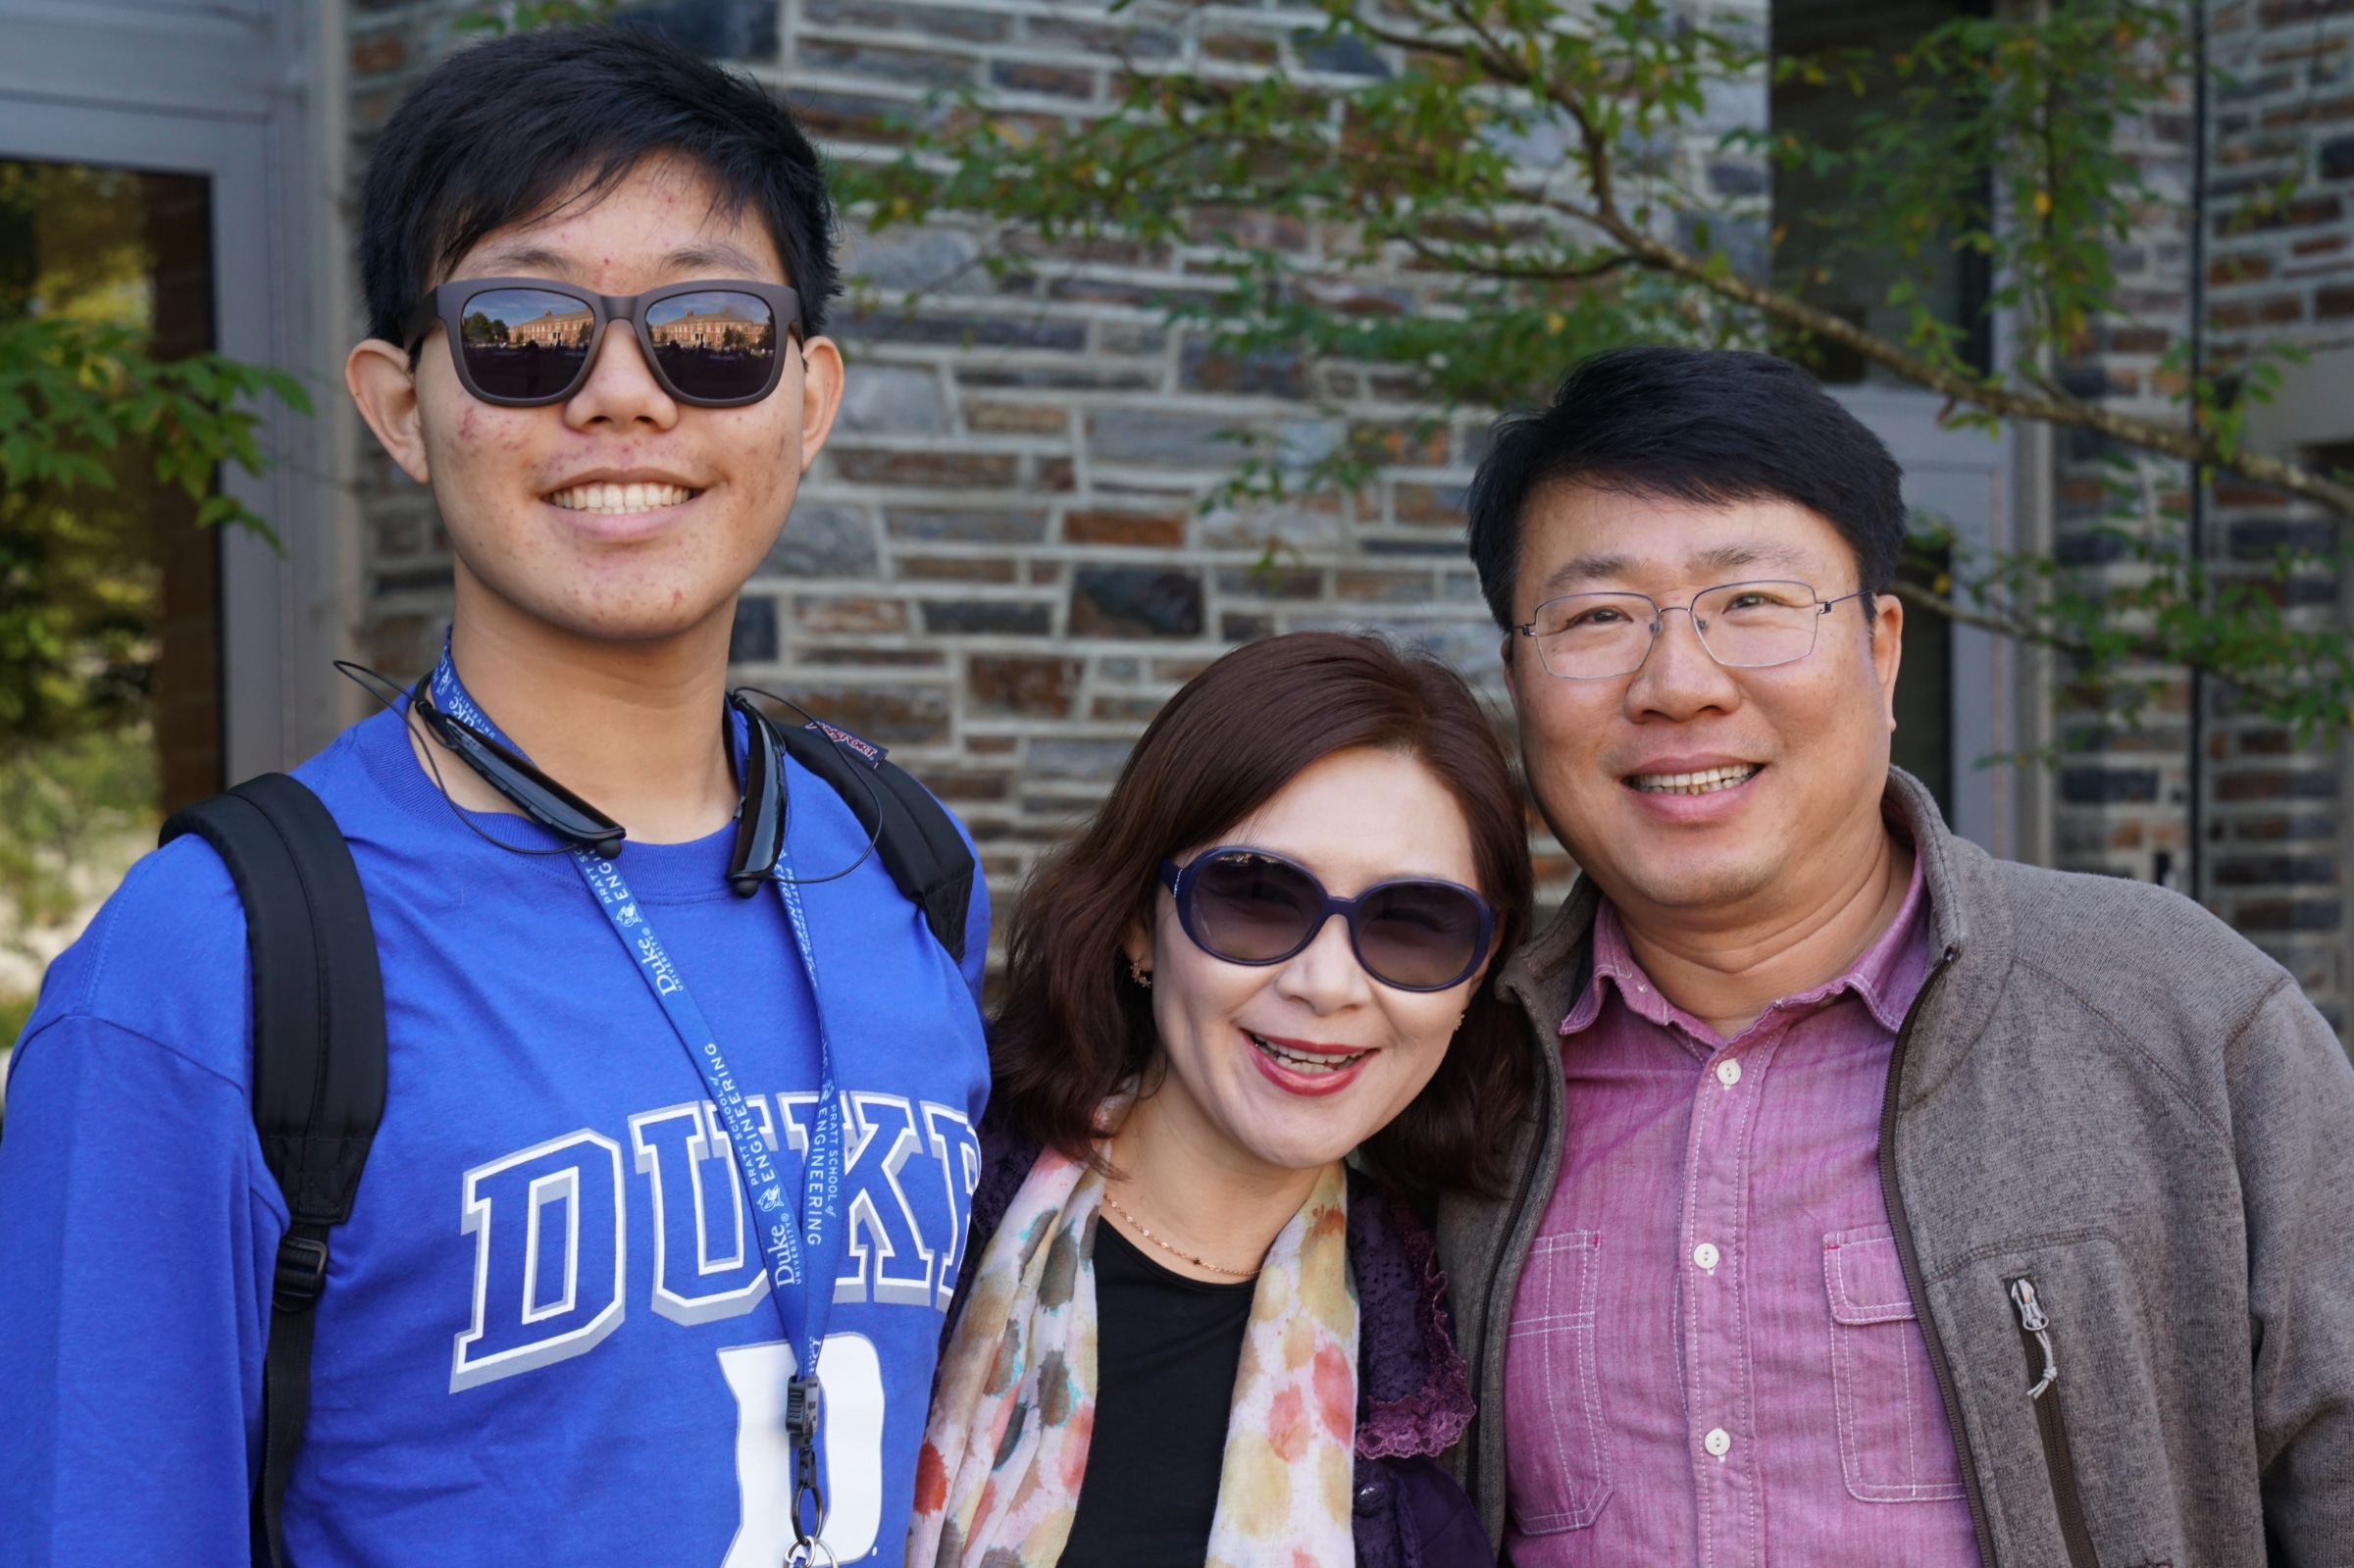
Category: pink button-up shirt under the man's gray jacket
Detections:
[{"x1": 1505, "y1": 842, "x2": 1977, "y2": 1568}]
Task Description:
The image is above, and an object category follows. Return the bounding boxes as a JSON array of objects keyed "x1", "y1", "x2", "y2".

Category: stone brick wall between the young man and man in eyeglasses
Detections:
[{"x1": 351, "y1": 0, "x2": 1764, "y2": 950}]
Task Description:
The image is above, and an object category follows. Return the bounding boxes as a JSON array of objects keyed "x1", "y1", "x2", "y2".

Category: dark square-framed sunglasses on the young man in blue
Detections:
[{"x1": 402, "y1": 278, "x2": 800, "y2": 407}]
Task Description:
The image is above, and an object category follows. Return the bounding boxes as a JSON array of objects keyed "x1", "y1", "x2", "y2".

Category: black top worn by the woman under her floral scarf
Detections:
[{"x1": 1061, "y1": 1220, "x2": 1257, "y2": 1568}]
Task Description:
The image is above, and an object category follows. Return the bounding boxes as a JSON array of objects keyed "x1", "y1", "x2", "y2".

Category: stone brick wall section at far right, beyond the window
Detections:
[{"x1": 2058, "y1": 0, "x2": 2354, "y2": 1029}]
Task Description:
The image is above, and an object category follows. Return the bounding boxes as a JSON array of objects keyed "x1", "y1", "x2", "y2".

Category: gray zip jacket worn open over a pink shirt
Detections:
[{"x1": 1438, "y1": 770, "x2": 2354, "y2": 1568}]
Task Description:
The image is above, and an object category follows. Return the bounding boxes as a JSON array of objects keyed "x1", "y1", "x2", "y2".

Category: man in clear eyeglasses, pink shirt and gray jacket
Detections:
[{"x1": 1441, "y1": 348, "x2": 2354, "y2": 1568}]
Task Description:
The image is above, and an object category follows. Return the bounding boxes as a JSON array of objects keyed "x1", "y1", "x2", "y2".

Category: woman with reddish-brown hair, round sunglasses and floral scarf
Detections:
[{"x1": 908, "y1": 633, "x2": 1532, "y2": 1568}]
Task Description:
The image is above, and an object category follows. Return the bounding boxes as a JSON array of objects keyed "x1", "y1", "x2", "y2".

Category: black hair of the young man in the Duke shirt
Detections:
[{"x1": 360, "y1": 28, "x2": 836, "y2": 346}]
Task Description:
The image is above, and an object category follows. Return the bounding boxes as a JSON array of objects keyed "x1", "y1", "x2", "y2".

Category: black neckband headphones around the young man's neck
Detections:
[{"x1": 350, "y1": 659, "x2": 883, "y2": 899}]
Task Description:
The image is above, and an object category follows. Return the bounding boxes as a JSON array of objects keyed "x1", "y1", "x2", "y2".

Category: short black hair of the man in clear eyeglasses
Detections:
[{"x1": 1469, "y1": 348, "x2": 1905, "y2": 631}]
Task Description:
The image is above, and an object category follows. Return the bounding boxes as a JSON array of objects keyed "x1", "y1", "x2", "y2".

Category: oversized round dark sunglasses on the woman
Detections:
[{"x1": 1160, "y1": 845, "x2": 1495, "y2": 991}]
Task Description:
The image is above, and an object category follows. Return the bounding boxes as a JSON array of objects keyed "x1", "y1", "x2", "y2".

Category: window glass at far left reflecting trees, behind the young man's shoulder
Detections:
[{"x1": 0, "y1": 160, "x2": 222, "y2": 1045}]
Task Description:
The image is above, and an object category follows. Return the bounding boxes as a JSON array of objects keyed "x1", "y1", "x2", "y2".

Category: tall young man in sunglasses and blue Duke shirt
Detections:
[{"x1": 0, "y1": 30, "x2": 989, "y2": 1568}]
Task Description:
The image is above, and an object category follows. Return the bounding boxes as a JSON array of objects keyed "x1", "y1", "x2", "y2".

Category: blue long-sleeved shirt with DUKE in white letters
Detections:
[{"x1": 0, "y1": 716, "x2": 989, "y2": 1568}]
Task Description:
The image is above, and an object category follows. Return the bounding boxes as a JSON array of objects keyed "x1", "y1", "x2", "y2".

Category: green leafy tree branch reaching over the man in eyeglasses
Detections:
[{"x1": 838, "y1": 0, "x2": 2354, "y2": 733}]
